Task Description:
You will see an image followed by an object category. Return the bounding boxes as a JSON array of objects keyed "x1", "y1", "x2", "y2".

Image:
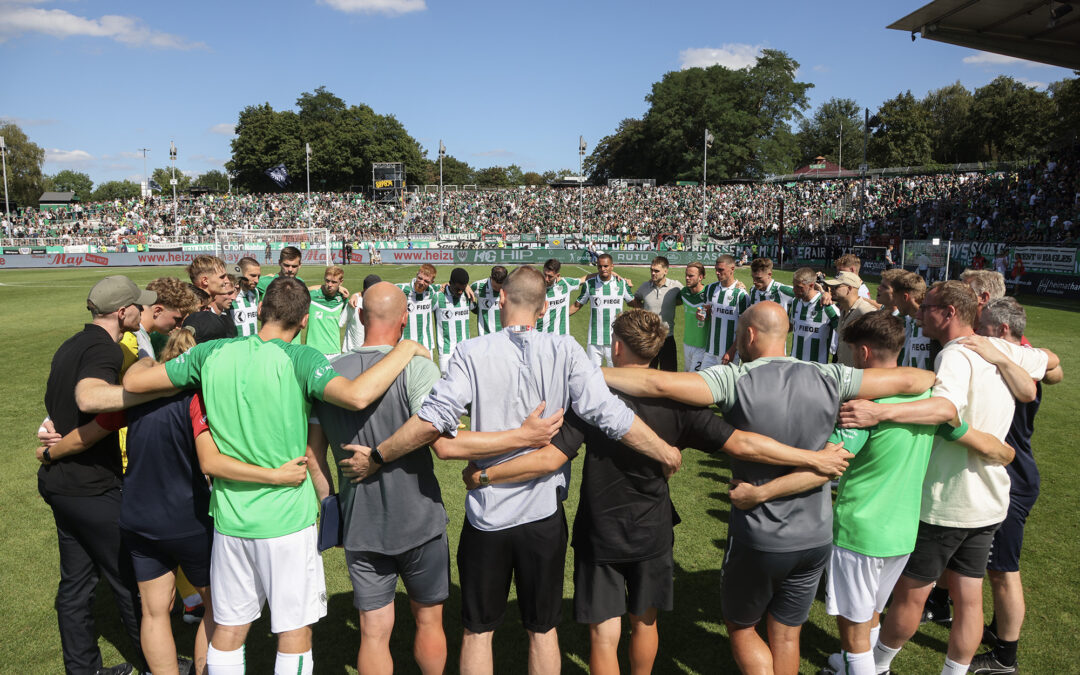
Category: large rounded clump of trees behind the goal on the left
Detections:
[{"x1": 226, "y1": 86, "x2": 423, "y2": 192}]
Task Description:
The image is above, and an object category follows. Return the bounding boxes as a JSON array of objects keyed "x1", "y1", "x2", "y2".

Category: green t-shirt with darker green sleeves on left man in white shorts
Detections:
[{"x1": 165, "y1": 335, "x2": 338, "y2": 539}]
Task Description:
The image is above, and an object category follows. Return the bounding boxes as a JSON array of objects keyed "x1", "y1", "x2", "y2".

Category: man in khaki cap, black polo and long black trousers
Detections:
[{"x1": 38, "y1": 276, "x2": 158, "y2": 675}]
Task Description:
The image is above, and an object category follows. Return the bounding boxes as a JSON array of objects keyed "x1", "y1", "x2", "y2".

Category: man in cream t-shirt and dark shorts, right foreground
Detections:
[{"x1": 840, "y1": 281, "x2": 1057, "y2": 675}]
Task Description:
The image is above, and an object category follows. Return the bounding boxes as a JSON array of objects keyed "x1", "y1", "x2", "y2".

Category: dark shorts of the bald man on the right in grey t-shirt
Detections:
[{"x1": 720, "y1": 537, "x2": 833, "y2": 626}]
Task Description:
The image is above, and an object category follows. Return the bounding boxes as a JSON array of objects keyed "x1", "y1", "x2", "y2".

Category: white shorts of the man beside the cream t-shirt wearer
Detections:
[{"x1": 825, "y1": 545, "x2": 910, "y2": 623}]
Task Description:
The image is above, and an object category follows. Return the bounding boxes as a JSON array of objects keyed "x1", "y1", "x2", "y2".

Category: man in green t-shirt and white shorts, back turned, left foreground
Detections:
[{"x1": 124, "y1": 278, "x2": 427, "y2": 675}]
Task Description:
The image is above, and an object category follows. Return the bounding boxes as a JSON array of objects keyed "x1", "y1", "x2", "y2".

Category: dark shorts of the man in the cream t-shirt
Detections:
[{"x1": 904, "y1": 521, "x2": 1000, "y2": 583}]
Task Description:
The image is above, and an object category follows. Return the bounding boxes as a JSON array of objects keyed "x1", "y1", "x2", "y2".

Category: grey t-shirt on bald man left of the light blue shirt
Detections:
[{"x1": 311, "y1": 346, "x2": 447, "y2": 555}]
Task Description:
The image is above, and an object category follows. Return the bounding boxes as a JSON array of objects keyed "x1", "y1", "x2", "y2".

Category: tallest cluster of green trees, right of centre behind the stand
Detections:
[{"x1": 585, "y1": 50, "x2": 812, "y2": 183}]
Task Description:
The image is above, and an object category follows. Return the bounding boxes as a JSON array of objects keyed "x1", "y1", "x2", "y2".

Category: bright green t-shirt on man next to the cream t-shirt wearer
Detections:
[{"x1": 829, "y1": 391, "x2": 936, "y2": 557}]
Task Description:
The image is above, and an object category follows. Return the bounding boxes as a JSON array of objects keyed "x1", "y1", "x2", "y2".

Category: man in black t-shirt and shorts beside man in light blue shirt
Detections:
[{"x1": 463, "y1": 309, "x2": 850, "y2": 674}]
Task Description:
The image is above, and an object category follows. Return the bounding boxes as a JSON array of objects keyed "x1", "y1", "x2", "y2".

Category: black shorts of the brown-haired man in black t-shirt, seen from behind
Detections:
[{"x1": 573, "y1": 550, "x2": 675, "y2": 623}]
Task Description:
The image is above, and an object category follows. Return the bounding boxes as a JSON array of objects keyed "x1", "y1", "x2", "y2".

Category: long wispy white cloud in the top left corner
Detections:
[{"x1": 0, "y1": 2, "x2": 206, "y2": 50}]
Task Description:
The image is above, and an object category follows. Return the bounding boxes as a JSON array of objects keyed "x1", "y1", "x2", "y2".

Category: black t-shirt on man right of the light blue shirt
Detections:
[{"x1": 552, "y1": 392, "x2": 735, "y2": 565}]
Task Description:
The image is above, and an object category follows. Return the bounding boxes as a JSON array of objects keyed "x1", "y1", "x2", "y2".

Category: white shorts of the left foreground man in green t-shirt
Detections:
[{"x1": 210, "y1": 525, "x2": 326, "y2": 633}]
